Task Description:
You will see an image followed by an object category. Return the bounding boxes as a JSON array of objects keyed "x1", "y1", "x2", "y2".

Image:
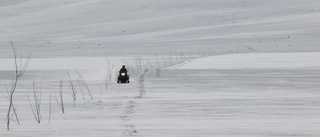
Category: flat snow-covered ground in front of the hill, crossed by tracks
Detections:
[{"x1": 1, "y1": 52, "x2": 320, "y2": 137}]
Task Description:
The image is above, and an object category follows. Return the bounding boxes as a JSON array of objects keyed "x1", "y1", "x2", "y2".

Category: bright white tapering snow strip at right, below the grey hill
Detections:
[{"x1": 170, "y1": 52, "x2": 320, "y2": 69}]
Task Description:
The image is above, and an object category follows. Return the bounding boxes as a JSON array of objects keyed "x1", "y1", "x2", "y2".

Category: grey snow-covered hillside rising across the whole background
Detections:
[{"x1": 0, "y1": 0, "x2": 320, "y2": 57}]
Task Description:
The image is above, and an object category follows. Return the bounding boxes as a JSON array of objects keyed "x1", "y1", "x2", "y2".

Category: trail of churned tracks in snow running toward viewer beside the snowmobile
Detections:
[{"x1": 120, "y1": 69, "x2": 149, "y2": 136}]
